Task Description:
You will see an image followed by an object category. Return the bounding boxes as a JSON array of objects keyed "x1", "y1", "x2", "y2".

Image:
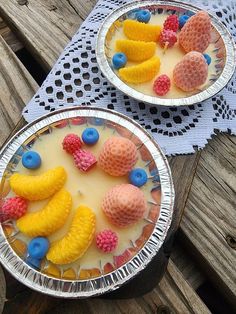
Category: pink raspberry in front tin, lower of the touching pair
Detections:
[{"x1": 73, "y1": 149, "x2": 97, "y2": 171}]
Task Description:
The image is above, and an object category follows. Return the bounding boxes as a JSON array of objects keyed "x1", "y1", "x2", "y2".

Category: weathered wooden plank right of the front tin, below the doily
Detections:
[{"x1": 181, "y1": 134, "x2": 236, "y2": 304}]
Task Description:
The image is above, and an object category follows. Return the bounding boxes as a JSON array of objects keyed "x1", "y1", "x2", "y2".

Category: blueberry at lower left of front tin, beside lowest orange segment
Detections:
[{"x1": 28, "y1": 237, "x2": 49, "y2": 259}]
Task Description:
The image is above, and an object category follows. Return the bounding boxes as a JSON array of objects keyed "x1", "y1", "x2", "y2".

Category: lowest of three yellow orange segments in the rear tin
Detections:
[{"x1": 119, "y1": 57, "x2": 160, "y2": 84}]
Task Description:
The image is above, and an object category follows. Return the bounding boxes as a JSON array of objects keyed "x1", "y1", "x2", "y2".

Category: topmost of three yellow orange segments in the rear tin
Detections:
[{"x1": 123, "y1": 20, "x2": 161, "y2": 42}]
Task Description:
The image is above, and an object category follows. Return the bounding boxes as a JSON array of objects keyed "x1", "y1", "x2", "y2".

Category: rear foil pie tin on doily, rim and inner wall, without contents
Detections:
[{"x1": 96, "y1": 0, "x2": 236, "y2": 107}]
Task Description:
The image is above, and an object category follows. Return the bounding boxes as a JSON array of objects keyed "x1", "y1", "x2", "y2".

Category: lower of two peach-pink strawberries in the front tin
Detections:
[{"x1": 102, "y1": 183, "x2": 146, "y2": 228}]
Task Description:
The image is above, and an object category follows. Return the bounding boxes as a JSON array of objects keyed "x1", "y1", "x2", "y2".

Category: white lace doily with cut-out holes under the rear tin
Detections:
[{"x1": 23, "y1": 0, "x2": 236, "y2": 155}]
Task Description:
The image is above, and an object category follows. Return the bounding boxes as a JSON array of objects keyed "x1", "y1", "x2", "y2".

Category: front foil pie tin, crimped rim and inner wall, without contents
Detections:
[{"x1": 0, "y1": 107, "x2": 174, "y2": 298}]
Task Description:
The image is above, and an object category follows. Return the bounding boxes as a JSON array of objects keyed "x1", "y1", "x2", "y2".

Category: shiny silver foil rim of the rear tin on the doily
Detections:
[{"x1": 95, "y1": 0, "x2": 236, "y2": 107}]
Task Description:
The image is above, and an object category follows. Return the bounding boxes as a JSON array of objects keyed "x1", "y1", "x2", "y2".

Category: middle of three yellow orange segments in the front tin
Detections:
[{"x1": 16, "y1": 189, "x2": 72, "y2": 237}]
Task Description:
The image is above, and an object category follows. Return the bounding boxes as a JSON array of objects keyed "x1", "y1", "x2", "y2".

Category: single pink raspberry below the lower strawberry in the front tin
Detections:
[{"x1": 96, "y1": 230, "x2": 118, "y2": 253}]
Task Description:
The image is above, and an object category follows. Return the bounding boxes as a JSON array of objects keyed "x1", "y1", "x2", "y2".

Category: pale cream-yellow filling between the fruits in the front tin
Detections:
[{"x1": 4, "y1": 124, "x2": 161, "y2": 278}]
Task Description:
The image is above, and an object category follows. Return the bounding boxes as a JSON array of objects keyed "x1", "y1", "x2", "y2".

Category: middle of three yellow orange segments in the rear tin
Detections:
[{"x1": 116, "y1": 39, "x2": 157, "y2": 62}]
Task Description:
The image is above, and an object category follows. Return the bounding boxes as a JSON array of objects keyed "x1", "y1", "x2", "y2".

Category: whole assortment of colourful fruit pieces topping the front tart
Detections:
[{"x1": 0, "y1": 119, "x2": 160, "y2": 277}]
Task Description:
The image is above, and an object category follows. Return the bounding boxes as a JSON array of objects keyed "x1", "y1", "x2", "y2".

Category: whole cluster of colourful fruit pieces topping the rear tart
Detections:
[{"x1": 112, "y1": 9, "x2": 211, "y2": 96}]
